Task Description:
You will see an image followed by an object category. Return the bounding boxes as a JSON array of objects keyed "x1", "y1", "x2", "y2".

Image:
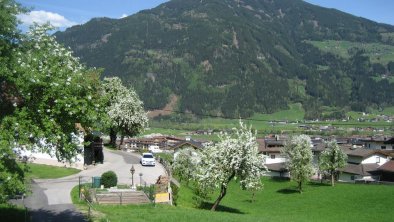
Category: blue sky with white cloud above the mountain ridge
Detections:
[{"x1": 16, "y1": 0, "x2": 394, "y2": 30}]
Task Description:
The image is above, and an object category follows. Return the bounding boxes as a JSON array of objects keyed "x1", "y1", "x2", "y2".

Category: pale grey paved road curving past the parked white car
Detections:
[{"x1": 20, "y1": 150, "x2": 165, "y2": 222}]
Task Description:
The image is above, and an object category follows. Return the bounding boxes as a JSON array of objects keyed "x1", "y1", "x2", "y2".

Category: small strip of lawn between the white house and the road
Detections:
[{"x1": 26, "y1": 163, "x2": 80, "y2": 179}]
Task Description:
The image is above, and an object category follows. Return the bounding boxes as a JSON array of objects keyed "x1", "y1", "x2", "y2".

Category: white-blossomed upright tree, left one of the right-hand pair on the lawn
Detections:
[{"x1": 282, "y1": 135, "x2": 313, "y2": 193}]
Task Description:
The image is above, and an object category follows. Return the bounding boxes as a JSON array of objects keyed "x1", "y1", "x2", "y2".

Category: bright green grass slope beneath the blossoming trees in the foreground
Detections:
[{"x1": 73, "y1": 179, "x2": 394, "y2": 222}]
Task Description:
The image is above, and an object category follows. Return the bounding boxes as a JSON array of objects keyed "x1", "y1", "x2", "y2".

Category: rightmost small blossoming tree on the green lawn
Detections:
[{"x1": 319, "y1": 140, "x2": 347, "y2": 186}]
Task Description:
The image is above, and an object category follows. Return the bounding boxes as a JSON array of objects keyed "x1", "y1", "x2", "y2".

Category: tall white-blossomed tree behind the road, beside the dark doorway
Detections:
[{"x1": 103, "y1": 77, "x2": 148, "y2": 146}]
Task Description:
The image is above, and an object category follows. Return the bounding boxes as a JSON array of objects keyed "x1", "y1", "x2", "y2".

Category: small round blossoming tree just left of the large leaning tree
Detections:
[{"x1": 171, "y1": 147, "x2": 201, "y2": 184}]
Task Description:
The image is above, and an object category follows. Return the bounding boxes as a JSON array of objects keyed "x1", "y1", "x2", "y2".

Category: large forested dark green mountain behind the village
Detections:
[{"x1": 55, "y1": 0, "x2": 394, "y2": 118}]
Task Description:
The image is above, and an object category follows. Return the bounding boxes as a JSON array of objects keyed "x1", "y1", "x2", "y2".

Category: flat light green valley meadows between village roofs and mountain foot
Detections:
[{"x1": 145, "y1": 103, "x2": 394, "y2": 138}]
